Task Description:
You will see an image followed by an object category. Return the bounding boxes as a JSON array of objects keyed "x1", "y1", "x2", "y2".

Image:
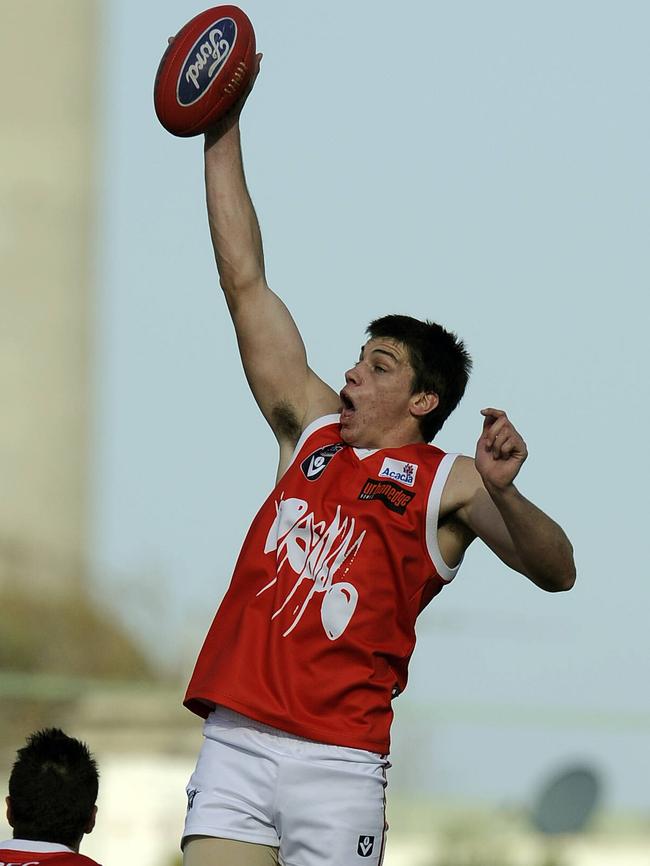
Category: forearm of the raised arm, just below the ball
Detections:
[{"x1": 205, "y1": 124, "x2": 265, "y2": 302}]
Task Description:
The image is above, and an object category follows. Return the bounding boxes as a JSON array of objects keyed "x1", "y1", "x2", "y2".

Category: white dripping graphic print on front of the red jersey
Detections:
[{"x1": 257, "y1": 494, "x2": 366, "y2": 640}]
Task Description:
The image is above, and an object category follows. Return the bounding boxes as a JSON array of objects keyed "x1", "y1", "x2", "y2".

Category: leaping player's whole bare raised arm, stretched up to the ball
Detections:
[{"x1": 204, "y1": 62, "x2": 340, "y2": 464}]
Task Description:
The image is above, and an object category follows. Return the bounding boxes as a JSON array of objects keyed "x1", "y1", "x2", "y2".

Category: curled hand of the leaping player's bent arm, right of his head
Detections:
[{"x1": 474, "y1": 408, "x2": 528, "y2": 489}]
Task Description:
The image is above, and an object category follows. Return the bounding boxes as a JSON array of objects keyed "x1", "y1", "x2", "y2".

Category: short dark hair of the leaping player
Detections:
[{"x1": 366, "y1": 315, "x2": 472, "y2": 442}]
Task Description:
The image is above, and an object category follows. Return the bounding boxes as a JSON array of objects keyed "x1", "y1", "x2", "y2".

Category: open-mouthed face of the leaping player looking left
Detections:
[{"x1": 341, "y1": 337, "x2": 422, "y2": 448}]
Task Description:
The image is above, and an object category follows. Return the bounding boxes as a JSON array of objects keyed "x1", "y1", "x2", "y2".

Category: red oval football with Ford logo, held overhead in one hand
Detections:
[{"x1": 153, "y1": 6, "x2": 255, "y2": 136}]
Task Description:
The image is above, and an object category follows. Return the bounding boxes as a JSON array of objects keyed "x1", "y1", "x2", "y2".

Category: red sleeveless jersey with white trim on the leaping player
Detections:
[{"x1": 185, "y1": 415, "x2": 458, "y2": 754}]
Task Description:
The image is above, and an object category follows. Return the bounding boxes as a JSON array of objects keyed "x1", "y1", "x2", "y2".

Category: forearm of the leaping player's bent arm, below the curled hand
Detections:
[{"x1": 486, "y1": 484, "x2": 576, "y2": 592}]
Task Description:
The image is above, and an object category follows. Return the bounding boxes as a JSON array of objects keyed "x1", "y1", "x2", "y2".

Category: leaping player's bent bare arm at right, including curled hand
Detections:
[{"x1": 450, "y1": 408, "x2": 576, "y2": 592}]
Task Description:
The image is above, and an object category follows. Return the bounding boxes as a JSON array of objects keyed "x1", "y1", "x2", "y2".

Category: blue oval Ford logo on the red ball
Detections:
[{"x1": 176, "y1": 18, "x2": 237, "y2": 106}]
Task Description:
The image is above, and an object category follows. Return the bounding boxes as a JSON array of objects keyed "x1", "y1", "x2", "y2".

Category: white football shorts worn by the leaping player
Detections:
[{"x1": 183, "y1": 707, "x2": 390, "y2": 866}]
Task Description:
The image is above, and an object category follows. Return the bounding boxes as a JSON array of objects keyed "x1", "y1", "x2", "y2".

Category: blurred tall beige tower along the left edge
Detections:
[{"x1": 0, "y1": 0, "x2": 98, "y2": 596}]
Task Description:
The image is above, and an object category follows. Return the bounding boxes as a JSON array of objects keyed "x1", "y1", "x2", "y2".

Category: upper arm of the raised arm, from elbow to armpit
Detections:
[{"x1": 226, "y1": 280, "x2": 339, "y2": 442}]
